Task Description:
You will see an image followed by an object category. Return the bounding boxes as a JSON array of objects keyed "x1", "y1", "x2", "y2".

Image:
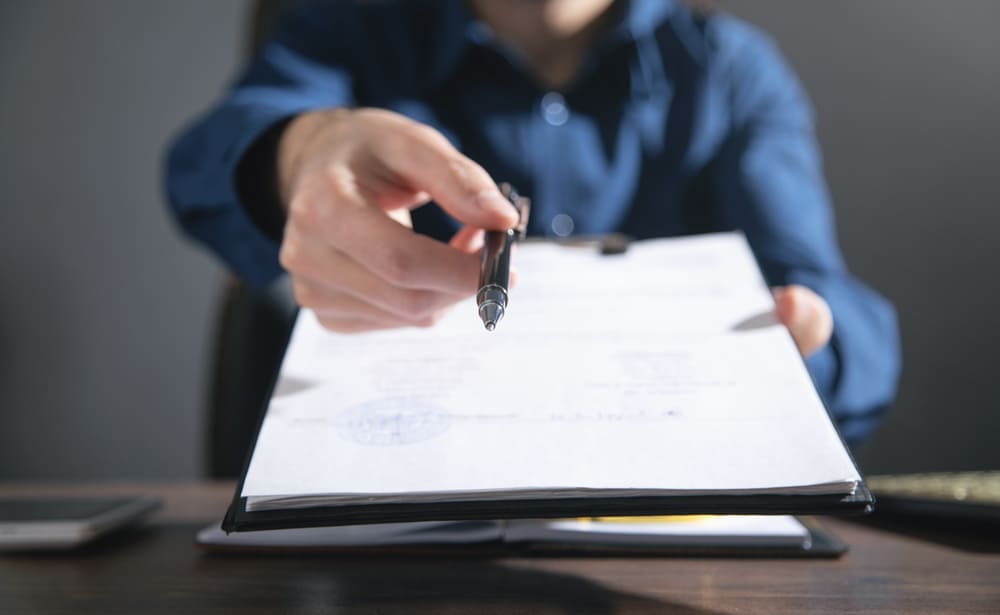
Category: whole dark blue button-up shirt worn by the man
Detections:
[{"x1": 167, "y1": 0, "x2": 899, "y2": 442}]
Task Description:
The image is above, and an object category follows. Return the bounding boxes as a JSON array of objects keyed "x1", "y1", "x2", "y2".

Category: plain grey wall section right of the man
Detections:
[{"x1": 726, "y1": 0, "x2": 1000, "y2": 472}]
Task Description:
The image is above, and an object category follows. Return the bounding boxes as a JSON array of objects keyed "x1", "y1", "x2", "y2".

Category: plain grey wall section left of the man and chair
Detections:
[{"x1": 0, "y1": 0, "x2": 246, "y2": 479}]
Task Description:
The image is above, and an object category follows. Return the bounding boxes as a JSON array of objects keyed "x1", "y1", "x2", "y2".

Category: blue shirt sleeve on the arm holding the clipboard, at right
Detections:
[{"x1": 714, "y1": 20, "x2": 900, "y2": 444}]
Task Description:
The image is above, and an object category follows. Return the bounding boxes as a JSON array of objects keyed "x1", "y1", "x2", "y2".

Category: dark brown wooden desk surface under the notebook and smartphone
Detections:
[{"x1": 0, "y1": 483, "x2": 1000, "y2": 614}]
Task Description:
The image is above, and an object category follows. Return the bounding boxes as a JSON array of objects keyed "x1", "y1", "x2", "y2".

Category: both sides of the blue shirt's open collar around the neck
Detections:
[{"x1": 430, "y1": 0, "x2": 675, "y2": 87}]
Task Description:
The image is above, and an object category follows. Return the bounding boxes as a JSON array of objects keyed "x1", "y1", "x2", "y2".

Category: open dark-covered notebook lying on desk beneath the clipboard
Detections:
[{"x1": 207, "y1": 515, "x2": 847, "y2": 558}]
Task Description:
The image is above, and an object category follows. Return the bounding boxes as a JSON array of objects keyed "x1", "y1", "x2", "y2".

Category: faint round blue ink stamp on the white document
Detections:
[{"x1": 336, "y1": 397, "x2": 451, "y2": 446}]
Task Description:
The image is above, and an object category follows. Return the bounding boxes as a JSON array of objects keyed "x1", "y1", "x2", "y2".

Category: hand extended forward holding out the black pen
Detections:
[{"x1": 278, "y1": 109, "x2": 517, "y2": 332}]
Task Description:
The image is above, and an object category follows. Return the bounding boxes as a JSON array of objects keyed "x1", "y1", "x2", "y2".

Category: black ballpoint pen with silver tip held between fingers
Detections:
[{"x1": 476, "y1": 183, "x2": 531, "y2": 331}]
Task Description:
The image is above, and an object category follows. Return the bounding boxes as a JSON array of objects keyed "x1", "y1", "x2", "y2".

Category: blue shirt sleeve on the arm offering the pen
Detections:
[{"x1": 165, "y1": 3, "x2": 361, "y2": 287}]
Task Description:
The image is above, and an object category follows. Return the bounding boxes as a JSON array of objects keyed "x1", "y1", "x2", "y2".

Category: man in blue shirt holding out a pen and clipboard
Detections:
[{"x1": 166, "y1": 0, "x2": 900, "y2": 443}]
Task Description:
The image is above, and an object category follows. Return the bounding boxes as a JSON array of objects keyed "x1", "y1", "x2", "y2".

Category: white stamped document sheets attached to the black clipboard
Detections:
[{"x1": 241, "y1": 233, "x2": 861, "y2": 512}]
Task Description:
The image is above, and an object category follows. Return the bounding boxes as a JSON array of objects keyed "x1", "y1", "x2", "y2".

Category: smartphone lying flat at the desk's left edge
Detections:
[{"x1": 0, "y1": 496, "x2": 160, "y2": 551}]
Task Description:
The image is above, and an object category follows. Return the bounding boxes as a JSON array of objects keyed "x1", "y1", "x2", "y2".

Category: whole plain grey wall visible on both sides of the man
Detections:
[{"x1": 0, "y1": 0, "x2": 1000, "y2": 479}]
